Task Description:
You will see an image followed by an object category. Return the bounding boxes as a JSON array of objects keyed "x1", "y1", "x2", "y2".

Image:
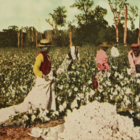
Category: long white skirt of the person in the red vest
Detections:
[{"x1": 14, "y1": 71, "x2": 56, "y2": 113}]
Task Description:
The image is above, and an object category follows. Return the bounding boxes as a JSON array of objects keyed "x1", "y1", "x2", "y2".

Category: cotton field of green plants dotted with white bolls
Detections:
[{"x1": 0, "y1": 46, "x2": 140, "y2": 128}]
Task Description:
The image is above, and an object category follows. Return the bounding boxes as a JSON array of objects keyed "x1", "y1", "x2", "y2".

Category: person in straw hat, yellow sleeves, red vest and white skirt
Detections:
[{"x1": 15, "y1": 39, "x2": 56, "y2": 112}]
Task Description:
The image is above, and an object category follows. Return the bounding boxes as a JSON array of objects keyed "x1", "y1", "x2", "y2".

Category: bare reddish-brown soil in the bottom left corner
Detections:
[{"x1": 0, "y1": 120, "x2": 64, "y2": 140}]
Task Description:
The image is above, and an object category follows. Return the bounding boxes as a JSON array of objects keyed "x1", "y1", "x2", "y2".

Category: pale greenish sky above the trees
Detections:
[{"x1": 0, "y1": 0, "x2": 140, "y2": 32}]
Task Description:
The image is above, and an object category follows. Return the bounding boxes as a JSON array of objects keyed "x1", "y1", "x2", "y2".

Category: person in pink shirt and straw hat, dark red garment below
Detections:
[{"x1": 93, "y1": 42, "x2": 110, "y2": 89}]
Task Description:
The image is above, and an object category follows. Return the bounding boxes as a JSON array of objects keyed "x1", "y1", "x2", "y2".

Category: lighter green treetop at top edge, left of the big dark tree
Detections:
[{"x1": 70, "y1": 0, "x2": 94, "y2": 25}]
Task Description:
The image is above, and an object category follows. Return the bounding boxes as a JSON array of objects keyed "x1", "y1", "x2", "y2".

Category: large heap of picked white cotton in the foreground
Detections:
[{"x1": 58, "y1": 101, "x2": 140, "y2": 140}]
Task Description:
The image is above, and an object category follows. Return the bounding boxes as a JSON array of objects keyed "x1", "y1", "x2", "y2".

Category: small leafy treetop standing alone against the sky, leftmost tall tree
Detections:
[{"x1": 46, "y1": 6, "x2": 67, "y2": 34}]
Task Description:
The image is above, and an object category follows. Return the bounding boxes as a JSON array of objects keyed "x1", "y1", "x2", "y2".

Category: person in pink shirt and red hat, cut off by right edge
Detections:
[{"x1": 128, "y1": 44, "x2": 140, "y2": 75}]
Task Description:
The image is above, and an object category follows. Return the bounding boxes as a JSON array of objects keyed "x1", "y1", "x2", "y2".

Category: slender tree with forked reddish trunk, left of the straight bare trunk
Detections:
[{"x1": 108, "y1": 0, "x2": 124, "y2": 43}]
